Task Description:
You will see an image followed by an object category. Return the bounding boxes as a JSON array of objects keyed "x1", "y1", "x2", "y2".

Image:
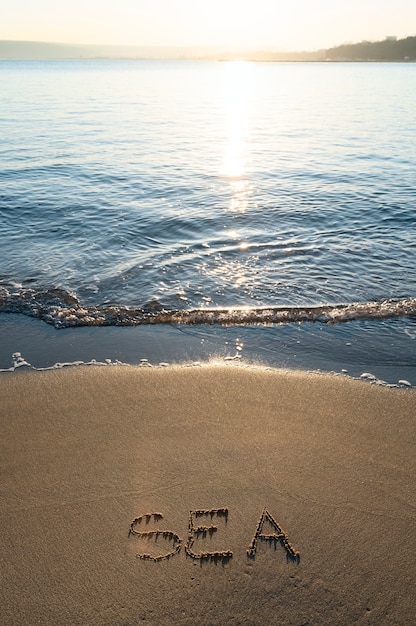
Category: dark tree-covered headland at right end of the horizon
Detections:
[{"x1": 326, "y1": 37, "x2": 416, "y2": 61}]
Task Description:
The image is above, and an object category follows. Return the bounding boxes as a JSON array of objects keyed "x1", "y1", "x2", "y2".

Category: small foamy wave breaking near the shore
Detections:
[{"x1": 0, "y1": 284, "x2": 416, "y2": 328}]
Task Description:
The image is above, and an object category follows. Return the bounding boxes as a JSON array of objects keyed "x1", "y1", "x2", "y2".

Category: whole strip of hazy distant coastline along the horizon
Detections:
[{"x1": 0, "y1": 36, "x2": 416, "y2": 62}]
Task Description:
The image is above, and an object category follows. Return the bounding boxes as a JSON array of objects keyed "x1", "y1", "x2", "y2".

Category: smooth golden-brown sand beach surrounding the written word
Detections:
[{"x1": 0, "y1": 366, "x2": 416, "y2": 626}]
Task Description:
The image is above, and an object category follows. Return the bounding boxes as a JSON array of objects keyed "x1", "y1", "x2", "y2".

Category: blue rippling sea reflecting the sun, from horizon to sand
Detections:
[{"x1": 0, "y1": 59, "x2": 416, "y2": 380}]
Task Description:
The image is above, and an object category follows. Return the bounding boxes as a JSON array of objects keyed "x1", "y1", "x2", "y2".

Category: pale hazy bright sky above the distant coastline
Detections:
[{"x1": 0, "y1": 0, "x2": 416, "y2": 50}]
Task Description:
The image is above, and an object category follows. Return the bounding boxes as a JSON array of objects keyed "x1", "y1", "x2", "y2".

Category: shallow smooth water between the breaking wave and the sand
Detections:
[{"x1": 0, "y1": 313, "x2": 416, "y2": 387}]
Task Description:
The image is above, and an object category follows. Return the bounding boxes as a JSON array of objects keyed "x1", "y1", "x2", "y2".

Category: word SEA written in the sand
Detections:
[{"x1": 129, "y1": 507, "x2": 300, "y2": 563}]
